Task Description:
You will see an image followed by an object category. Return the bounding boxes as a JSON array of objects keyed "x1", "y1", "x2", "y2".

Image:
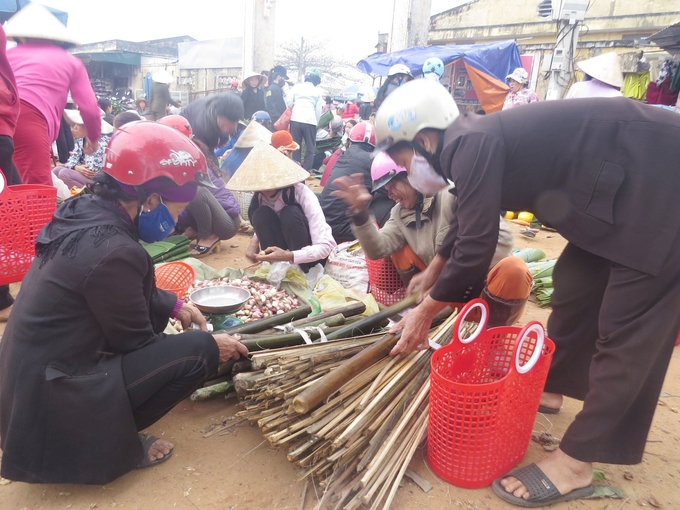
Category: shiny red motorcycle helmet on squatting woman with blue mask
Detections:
[{"x1": 102, "y1": 121, "x2": 215, "y2": 188}]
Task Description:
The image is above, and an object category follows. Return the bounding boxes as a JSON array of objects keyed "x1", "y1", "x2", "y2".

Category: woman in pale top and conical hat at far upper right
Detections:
[{"x1": 564, "y1": 51, "x2": 623, "y2": 99}]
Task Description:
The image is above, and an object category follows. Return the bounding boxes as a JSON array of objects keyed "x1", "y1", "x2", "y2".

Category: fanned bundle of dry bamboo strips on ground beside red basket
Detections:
[{"x1": 234, "y1": 313, "x2": 475, "y2": 510}]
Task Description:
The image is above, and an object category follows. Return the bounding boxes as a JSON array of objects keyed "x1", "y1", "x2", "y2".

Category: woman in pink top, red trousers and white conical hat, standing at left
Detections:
[{"x1": 5, "y1": 3, "x2": 101, "y2": 186}]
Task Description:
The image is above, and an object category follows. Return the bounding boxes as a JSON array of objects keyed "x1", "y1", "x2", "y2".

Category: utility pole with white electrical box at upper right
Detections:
[{"x1": 538, "y1": 0, "x2": 589, "y2": 101}]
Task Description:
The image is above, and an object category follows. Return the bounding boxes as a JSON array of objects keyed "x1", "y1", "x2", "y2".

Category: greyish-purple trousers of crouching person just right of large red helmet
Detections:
[{"x1": 186, "y1": 186, "x2": 241, "y2": 241}]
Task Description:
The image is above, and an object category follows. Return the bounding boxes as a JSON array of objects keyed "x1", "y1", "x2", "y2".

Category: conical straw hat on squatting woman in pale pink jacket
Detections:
[{"x1": 227, "y1": 143, "x2": 309, "y2": 191}]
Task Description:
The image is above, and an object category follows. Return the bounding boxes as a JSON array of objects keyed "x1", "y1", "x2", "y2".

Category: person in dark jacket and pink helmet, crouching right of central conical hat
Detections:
[{"x1": 319, "y1": 122, "x2": 395, "y2": 244}]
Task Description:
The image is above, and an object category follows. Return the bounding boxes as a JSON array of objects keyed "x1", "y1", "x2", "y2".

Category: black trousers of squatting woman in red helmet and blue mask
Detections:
[{"x1": 122, "y1": 331, "x2": 220, "y2": 430}]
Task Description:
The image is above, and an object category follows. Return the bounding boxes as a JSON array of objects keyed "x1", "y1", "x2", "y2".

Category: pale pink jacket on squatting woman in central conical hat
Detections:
[{"x1": 254, "y1": 182, "x2": 337, "y2": 264}]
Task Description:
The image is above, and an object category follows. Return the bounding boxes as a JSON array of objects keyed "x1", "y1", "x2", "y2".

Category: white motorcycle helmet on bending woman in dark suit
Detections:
[{"x1": 375, "y1": 79, "x2": 460, "y2": 150}]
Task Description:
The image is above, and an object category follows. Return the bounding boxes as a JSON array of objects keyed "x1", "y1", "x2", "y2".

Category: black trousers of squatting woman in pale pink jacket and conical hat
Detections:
[{"x1": 250, "y1": 205, "x2": 325, "y2": 273}]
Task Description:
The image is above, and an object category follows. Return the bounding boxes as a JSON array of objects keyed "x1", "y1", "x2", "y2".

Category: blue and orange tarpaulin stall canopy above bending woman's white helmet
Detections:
[{"x1": 357, "y1": 40, "x2": 522, "y2": 113}]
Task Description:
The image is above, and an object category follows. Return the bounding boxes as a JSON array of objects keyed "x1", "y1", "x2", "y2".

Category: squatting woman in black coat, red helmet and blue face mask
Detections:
[{"x1": 0, "y1": 122, "x2": 248, "y2": 484}]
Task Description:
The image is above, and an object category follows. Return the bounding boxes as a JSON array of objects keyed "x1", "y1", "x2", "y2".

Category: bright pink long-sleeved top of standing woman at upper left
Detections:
[{"x1": 7, "y1": 43, "x2": 102, "y2": 141}]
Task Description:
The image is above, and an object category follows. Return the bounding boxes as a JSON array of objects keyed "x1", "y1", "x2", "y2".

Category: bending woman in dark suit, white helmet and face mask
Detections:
[{"x1": 376, "y1": 80, "x2": 680, "y2": 507}]
